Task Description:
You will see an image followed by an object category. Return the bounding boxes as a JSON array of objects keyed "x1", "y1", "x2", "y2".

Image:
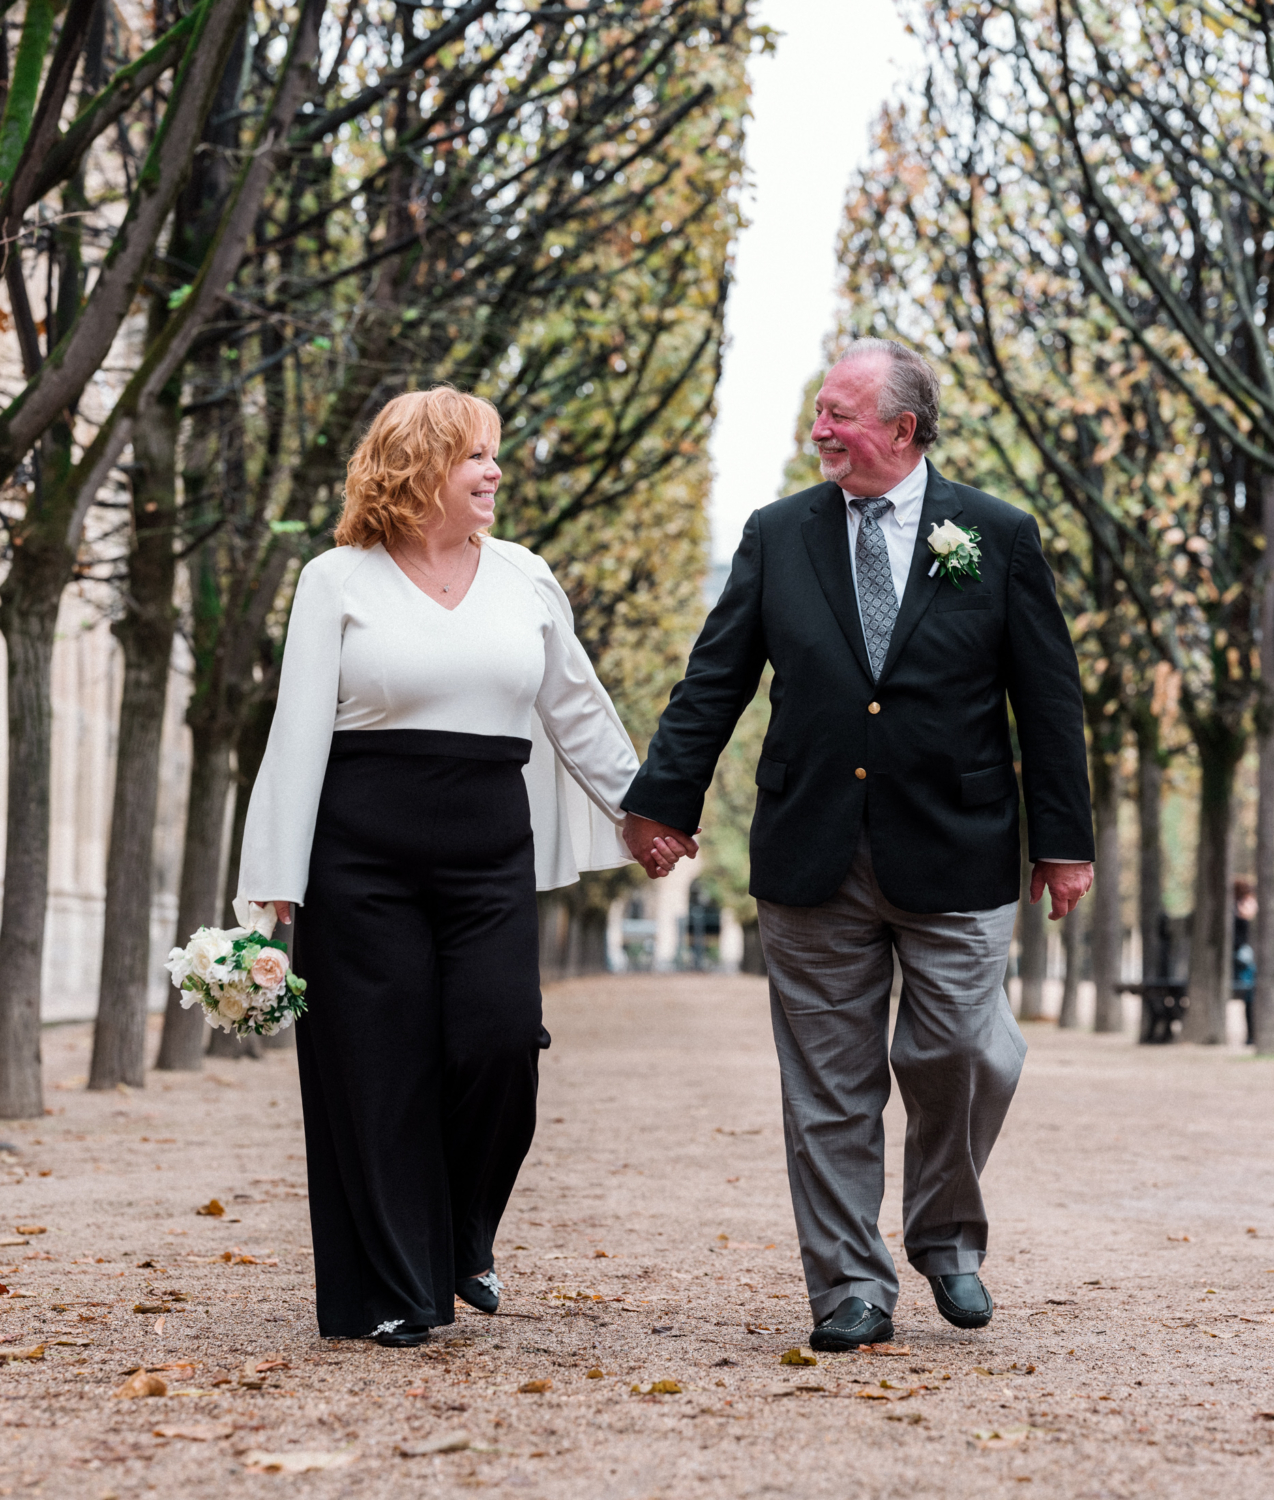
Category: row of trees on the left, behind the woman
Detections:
[{"x1": 0, "y1": 0, "x2": 768, "y2": 1116}]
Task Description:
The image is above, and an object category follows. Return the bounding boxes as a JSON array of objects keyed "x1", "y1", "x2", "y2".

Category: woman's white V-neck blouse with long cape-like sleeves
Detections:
[{"x1": 239, "y1": 537, "x2": 638, "y2": 902}]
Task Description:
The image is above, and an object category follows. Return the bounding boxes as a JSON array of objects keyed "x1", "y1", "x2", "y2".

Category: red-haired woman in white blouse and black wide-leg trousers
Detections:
[{"x1": 240, "y1": 387, "x2": 657, "y2": 1346}]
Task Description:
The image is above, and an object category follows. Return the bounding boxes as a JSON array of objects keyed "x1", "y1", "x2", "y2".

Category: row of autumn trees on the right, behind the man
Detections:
[{"x1": 774, "y1": 0, "x2": 1274, "y2": 1047}]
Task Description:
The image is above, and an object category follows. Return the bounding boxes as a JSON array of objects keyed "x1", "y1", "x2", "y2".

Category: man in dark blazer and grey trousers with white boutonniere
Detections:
[{"x1": 624, "y1": 339, "x2": 1092, "y2": 1350}]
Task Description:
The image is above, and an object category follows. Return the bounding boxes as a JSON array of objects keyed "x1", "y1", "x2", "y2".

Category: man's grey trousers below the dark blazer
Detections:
[{"x1": 756, "y1": 837, "x2": 1026, "y2": 1322}]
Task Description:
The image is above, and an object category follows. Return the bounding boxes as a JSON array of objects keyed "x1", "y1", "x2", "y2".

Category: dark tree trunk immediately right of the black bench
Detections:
[{"x1": 1181, "y1": 719, "x2": 1244, "y2": 1046}]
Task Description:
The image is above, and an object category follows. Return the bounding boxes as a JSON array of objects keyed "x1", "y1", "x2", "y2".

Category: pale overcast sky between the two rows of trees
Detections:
[{"x1": 711, "y1": 0, "x2": 918, "y2": 561}]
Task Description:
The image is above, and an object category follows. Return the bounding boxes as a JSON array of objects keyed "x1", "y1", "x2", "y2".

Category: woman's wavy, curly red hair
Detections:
[{"x1": 336, "y1": 386, "x2": 500, "y2": 549}]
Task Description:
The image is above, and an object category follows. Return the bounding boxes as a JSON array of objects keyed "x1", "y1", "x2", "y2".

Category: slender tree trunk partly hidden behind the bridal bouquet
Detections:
[{"x1": 155, "y1": 728, "x2": 230, "y2": 1073}]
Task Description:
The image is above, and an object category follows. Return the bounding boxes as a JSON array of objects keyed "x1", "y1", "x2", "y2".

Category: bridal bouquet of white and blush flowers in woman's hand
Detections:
[{"x1": 164, "y1": 897, "x2": 305, "y2": 1037}]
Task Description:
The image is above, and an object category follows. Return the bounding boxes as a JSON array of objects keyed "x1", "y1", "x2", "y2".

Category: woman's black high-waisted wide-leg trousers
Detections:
[{"x1": 296, "y1": 729, "x2": 549, "y2": 1338}]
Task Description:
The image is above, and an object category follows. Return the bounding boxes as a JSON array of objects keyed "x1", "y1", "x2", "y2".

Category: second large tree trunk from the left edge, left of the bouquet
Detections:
[{"x1": 89, "y1": 393, "x2": 180, "y2": 1089}]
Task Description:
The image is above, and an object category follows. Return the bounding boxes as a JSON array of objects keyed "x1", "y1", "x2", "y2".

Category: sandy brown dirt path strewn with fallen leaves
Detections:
[{"x1": 0, "y1": 975, "x2": 1274, "y2": 1500}]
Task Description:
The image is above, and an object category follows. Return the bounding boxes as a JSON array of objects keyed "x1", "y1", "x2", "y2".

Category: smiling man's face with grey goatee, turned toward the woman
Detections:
[{"x1": 810, "y1": 357, "x2": 917, "y2": 495}]
